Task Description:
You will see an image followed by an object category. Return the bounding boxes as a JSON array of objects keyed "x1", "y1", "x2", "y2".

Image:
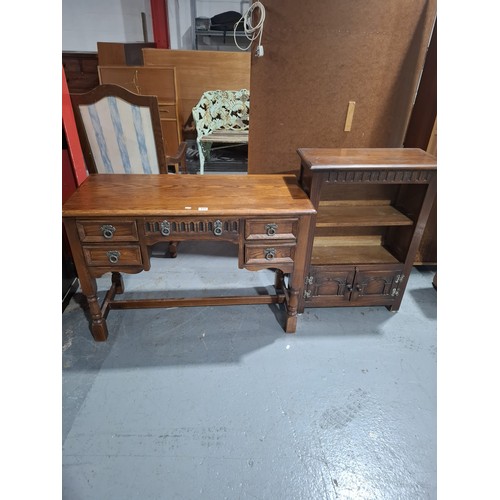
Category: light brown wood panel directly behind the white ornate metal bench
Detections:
[{"x1": 142, "y1": 49, "x2": 250, "y2": 129}]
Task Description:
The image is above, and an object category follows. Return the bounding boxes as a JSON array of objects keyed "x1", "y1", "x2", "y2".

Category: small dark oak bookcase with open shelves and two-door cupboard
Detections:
[{"x1": 297, "y1": 148, "x2": 437, "y2": 312}]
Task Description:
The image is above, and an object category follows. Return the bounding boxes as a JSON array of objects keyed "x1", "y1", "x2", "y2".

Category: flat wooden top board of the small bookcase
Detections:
[{"x1": 297, "y1": 148, "x2": 436, "y2": 170}]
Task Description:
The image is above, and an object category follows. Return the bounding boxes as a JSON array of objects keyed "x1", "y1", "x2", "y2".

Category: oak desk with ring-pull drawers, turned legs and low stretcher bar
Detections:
[{"x1": 63, "y1": 174, "x2": 315, "y2": 341}]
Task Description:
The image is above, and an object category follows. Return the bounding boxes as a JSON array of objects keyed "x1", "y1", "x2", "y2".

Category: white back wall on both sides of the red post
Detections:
[{"x1": 62, "y1": 0, "x2": 250, "y2": 52}]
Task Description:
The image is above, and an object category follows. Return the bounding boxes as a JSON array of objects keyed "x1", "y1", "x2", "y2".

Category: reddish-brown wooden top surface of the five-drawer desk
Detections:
[{"x1": 63, "y1": 174, "x2": 315, "y2": 217}]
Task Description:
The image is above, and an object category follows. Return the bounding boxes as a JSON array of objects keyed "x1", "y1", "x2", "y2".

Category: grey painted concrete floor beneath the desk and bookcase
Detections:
[{"x1": 62, "y1": 242, "x2": 437, "y2": 500}]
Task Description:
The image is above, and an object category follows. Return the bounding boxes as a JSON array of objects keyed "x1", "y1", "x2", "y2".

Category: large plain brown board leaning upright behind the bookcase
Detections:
[{"x1": 248, "y1": 0, "x2": 436, "y2": 173}]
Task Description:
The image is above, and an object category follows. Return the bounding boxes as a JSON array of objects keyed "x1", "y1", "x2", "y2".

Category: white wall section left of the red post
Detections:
[{"x1": 62, "y1": 0, "x2": 153, "y2": 52}]
